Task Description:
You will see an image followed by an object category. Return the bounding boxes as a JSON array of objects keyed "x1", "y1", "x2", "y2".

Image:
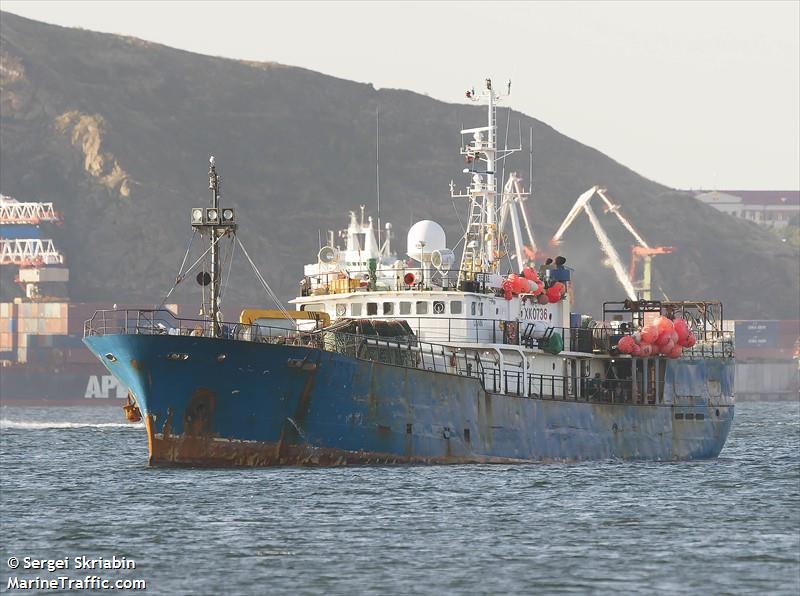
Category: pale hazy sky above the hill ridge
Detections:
[{"x1": 0, "y1": 0, "x2": 800, "y2": 190}]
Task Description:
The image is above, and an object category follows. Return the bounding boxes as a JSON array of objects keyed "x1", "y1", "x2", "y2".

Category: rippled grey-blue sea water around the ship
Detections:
[{"x1": 0, "y1": 402, "x2": 800, "y2": 595}]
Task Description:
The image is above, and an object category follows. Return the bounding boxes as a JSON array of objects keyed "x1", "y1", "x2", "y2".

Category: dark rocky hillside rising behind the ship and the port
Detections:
[{"x1": 0, "y1": 13, "x2": 800, "y2": 318}]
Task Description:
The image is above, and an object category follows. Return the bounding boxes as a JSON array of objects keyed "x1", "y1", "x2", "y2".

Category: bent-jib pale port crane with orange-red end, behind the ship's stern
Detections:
[{"x1": 551, "y1": 186, "x2": 675, "y2": 300}]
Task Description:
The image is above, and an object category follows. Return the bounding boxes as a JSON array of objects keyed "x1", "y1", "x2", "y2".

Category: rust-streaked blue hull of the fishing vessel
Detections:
[{"x1": 84, "y1": 335, "x2": 734, "y2": 466}]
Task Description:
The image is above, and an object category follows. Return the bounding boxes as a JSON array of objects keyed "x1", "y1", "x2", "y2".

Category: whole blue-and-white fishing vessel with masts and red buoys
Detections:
[{"x1": 84, "y1": 79, "x2": 734, "y2": 466}]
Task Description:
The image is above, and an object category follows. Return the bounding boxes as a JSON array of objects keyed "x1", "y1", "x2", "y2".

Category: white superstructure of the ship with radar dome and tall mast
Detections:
[{"x1": 292, "y1": 79, "x2": 570, "y2": 353}]
